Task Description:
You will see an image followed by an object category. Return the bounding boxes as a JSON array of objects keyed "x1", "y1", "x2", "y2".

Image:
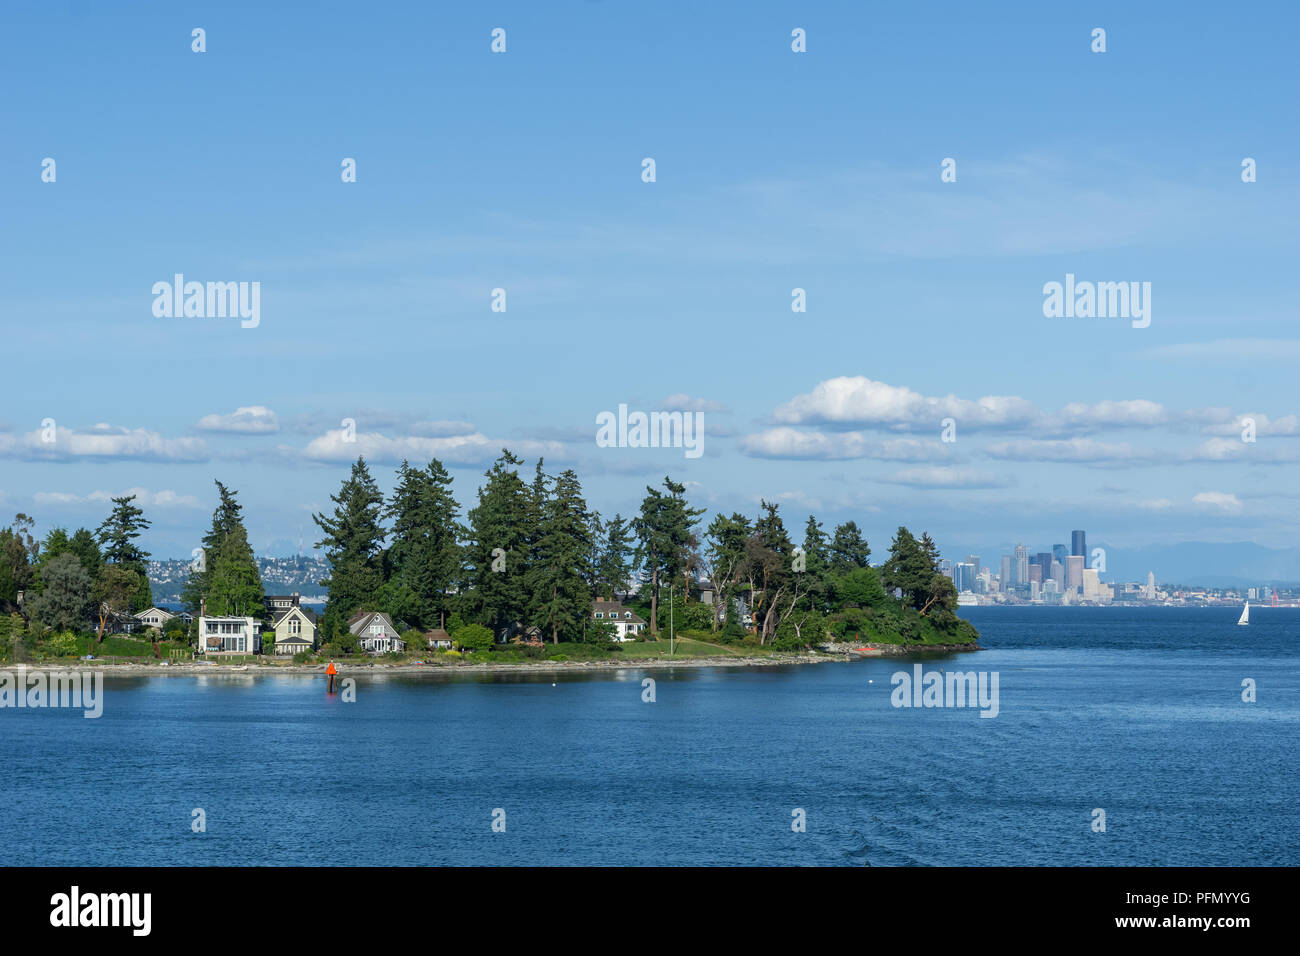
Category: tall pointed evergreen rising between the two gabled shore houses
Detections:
[{"x1": 312, "y1": 458, "x2": 384, "y2": 622}]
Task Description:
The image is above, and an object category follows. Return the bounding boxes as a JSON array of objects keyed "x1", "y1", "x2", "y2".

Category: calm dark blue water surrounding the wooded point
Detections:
[{"x1": 0, "y1": 609, "x2": 1300, "y2": 866}]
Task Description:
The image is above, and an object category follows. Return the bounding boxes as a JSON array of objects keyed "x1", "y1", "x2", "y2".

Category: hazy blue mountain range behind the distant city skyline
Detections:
[{"x1": 954, "y1": 538, "x2": 1300, "y2": 588}]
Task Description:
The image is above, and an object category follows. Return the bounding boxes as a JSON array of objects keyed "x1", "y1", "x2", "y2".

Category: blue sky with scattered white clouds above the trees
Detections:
[{"x1": 0, "y1": 0, "x2": 1300, "y2": 557}]
